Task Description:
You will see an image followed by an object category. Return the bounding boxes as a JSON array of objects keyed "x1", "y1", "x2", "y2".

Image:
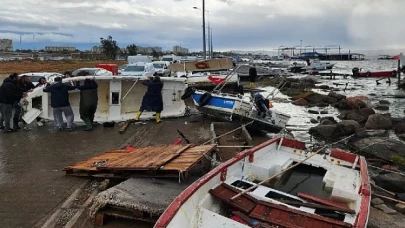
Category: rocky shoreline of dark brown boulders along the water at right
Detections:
[{"x1": 261, "y1": 76, "x2": 405, "y2": 227}]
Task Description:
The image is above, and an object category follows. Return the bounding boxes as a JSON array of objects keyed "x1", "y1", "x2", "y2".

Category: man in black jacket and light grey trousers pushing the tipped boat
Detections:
[{"x1": 44, "y1": 77, "x2": 76, "y2": 131}]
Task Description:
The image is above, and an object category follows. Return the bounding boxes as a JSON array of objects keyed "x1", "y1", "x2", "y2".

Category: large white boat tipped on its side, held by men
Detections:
[{"x1": 21, "y1": 76, "x2": 187, "y2": 123}]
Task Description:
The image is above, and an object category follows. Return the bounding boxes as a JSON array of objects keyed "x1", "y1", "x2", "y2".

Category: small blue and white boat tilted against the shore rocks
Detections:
[{"x1": 191, "y1": 90, "x2": 291, "y2": 133}]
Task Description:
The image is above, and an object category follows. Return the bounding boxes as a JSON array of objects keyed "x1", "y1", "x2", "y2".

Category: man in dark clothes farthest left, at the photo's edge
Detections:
[{"x1": 0, "y1": 73, "x2": 26, "y2": 132}]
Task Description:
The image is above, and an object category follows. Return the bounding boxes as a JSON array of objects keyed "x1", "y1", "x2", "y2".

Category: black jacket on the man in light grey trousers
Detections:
[{"x1": 44, "y1": 82, "x2": 76, "y2": 108}]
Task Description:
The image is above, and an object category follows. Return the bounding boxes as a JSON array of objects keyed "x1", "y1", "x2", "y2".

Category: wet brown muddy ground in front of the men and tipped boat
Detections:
[{"x1": 0, "y1": 116, "x2": 210, "y2": 227}]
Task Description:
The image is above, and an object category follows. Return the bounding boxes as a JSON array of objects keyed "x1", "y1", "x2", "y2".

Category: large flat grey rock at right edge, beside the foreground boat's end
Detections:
[{"x1": 351, "y1": 137, "x2": 405, "y2": 166}]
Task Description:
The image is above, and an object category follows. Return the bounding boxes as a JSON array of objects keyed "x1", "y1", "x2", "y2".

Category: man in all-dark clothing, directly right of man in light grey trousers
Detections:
[{"x1": 77, "y1": 72, "x2": 98, "y2": 131}]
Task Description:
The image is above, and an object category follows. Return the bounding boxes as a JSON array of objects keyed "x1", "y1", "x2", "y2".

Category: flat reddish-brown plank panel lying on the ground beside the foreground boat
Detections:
[{"x1": 64, "y1": 145, "x2": 216, "y2": 178}]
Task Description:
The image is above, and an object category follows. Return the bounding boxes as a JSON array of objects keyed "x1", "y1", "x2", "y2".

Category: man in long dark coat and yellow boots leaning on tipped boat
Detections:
[{"x1": 135, "y1": 76, "x2": 163, "y2": 123}]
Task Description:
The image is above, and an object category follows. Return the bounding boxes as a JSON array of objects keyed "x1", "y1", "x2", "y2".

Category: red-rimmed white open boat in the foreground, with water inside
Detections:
[{"x1": 155, "y1": 137, "x2": 370, "y2": 228}]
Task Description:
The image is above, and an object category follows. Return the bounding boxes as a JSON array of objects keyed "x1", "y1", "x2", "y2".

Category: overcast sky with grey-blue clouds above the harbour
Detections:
[{"x1": 0, "y1": 0, "x2": 405, "y2": 50}]
